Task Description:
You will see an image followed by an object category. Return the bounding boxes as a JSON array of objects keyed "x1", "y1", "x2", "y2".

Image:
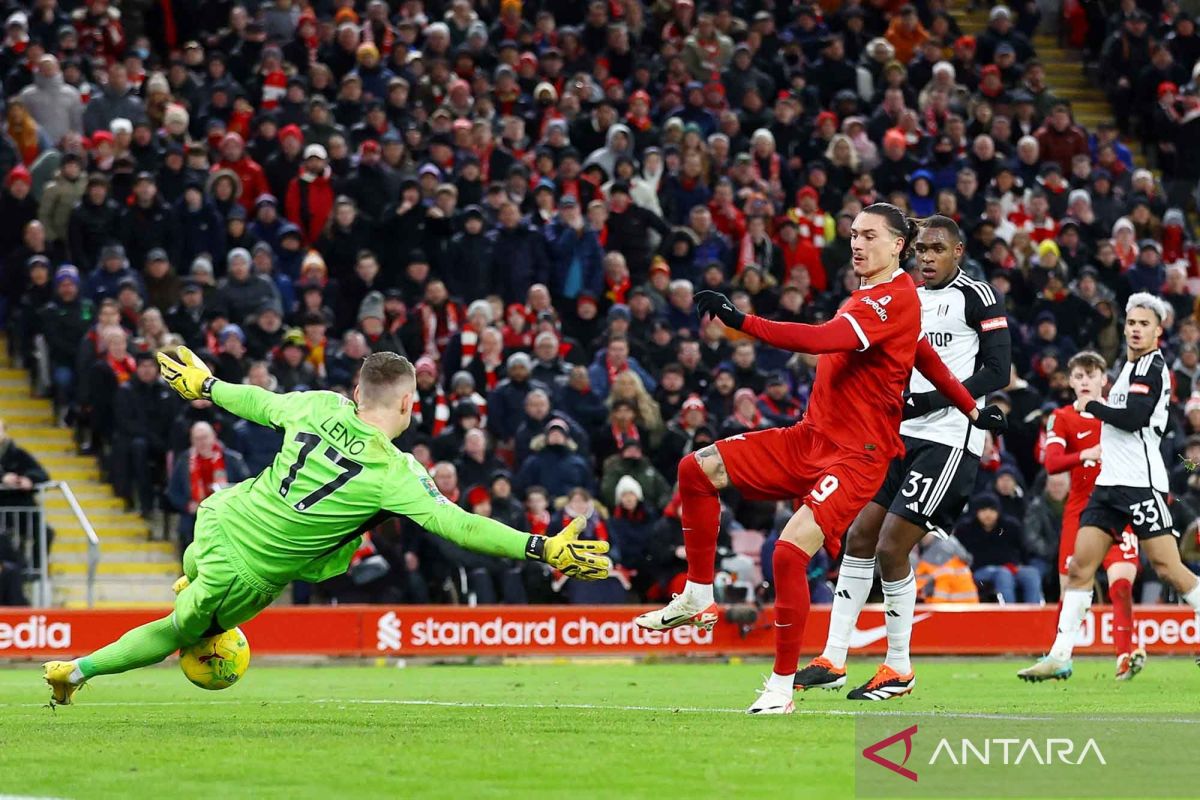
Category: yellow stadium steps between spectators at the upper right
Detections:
[{"x1": 950, "y1": 0, "x2": 1147, "y2": 167}]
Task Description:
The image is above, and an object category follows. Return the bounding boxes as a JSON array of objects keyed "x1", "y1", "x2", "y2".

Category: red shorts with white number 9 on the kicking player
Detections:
[{"x1": 716, "y1": 422, "x2": 890, "y2": 558}]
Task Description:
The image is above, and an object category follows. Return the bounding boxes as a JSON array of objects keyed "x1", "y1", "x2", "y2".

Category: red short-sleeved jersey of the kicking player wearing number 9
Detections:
[{"x1": 804, "y1": 270, "x2": 920, "y2": 458}]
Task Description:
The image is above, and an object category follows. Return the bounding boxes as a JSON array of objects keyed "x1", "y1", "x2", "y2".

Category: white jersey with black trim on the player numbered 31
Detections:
[{"x1": 900, "y1": 270, "x2": 1008, "y2": 456}]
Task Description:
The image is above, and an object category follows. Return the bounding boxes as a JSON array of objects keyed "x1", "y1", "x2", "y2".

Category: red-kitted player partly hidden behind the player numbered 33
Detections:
[{"x1": 1043, "y1": 350, "x2": 1146, "y2": 680}]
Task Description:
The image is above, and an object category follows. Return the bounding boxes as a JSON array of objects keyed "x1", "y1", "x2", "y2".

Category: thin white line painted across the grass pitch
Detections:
[{"x1": 0, "y1": 697, "x2": 1200, "y2": 724}]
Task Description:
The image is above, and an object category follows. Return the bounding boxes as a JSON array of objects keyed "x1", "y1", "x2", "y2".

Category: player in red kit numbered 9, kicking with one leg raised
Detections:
[{"x1": 636, "y1": 203, "x2": 1004, "y2": 714}]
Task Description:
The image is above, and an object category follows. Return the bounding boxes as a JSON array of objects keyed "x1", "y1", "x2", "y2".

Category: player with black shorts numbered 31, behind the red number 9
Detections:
[{"x1": 796, "y1": 215, "x2": 1013, "y2": 700}]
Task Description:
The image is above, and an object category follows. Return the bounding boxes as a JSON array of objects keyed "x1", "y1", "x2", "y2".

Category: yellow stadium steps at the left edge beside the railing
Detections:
[{"x1": 0, "y1": 333, "x2": 180, "y2": 608}]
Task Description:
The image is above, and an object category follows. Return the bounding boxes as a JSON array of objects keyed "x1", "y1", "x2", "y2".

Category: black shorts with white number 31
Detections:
[{"x1": 875, "y1": 437, "x2": 979, "y2": 533}]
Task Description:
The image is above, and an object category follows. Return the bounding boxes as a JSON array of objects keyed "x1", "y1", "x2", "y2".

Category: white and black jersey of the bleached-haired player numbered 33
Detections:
[{"x1": 1096, "y1": 350, "x2": 1171, "y2": 492}]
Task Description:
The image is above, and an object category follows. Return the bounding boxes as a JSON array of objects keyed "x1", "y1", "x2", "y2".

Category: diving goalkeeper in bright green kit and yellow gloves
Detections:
[{"x1": 44, "y1": 347, "x2": 608, "y2": 704}]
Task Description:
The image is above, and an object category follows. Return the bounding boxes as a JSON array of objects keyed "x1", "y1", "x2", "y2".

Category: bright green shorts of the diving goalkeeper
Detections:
[{"x1": 172, "y1": 509, "x2": 284, "y2": 642}]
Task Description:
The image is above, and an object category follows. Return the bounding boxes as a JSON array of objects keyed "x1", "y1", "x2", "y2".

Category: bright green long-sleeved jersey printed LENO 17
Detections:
[{"x1": 200, "y1": 383, "x2": 529, "y2": 584}]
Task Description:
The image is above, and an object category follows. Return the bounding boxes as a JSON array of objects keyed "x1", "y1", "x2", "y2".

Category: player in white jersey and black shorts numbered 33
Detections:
[{"x1": 1016, "y1": 291, "x2": 1200, "y2": 681}]
